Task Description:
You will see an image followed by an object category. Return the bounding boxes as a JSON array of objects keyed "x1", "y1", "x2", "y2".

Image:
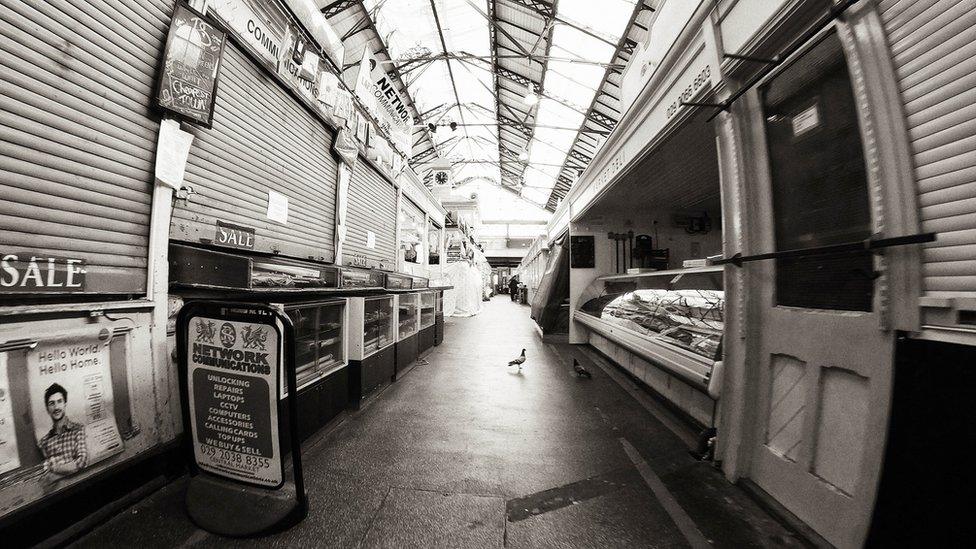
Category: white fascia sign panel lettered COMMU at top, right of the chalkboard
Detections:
[{"x1": 209, "y1": 0, "x2": 288, "y2": 72}]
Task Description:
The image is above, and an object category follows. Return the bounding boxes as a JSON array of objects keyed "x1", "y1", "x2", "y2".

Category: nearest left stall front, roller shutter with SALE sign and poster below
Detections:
[{"x1": 0, "y1": 0, "x2": 179, "y2": 536}]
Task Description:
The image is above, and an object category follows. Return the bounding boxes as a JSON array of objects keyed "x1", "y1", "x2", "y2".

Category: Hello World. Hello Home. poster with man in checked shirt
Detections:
[{"x1": 27, "y1": 327, "x2": 123, "y2": 481}]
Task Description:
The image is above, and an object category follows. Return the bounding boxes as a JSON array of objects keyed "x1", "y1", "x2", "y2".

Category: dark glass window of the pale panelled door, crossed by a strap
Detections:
[{"x1": 761, "y1": 34, "x2": 873, "y2": 311}]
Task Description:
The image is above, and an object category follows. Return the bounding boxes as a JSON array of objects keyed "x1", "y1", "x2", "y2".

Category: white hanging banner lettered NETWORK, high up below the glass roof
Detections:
[{"x1": 355, "y1": 48, "x2": 413, "y2": 157}]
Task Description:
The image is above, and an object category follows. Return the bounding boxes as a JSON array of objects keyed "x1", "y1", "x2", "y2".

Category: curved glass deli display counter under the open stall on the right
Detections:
[{"x1": 574, "y1": 267, "x2": 725, "y2": 389}]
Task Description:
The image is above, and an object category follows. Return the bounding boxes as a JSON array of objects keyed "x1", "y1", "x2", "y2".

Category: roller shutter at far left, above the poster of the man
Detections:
[{"x1": 0, "y1": 0, "x2": 172, "y2": 294}]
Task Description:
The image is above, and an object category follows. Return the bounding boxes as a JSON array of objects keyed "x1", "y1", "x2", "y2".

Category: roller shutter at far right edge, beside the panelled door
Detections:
[{"x1": 879, "y1": 0, "x2": 976, "y2": 296}]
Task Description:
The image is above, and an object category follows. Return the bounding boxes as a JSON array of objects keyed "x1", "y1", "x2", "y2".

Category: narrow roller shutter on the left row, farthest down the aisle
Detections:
[{"x1": 343, "y1": 158, "x2": 396, "y2": 269}]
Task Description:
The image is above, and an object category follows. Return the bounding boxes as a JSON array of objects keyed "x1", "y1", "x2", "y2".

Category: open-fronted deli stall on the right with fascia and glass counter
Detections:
[{"x1": 548, "y1": 1, "x2": 725, "y2": 428}]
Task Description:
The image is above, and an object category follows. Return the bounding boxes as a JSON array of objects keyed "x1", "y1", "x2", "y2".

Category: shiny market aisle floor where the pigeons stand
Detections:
[{"x1": 78, "y1": 296, "x2": 797, "y2": 548}]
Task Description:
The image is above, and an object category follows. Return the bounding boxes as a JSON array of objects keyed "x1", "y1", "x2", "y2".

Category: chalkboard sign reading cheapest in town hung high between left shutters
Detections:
[{"x1": 156, "y1": 2, "x2": 227, "y2": 128}]
